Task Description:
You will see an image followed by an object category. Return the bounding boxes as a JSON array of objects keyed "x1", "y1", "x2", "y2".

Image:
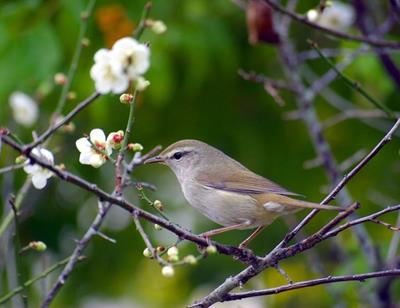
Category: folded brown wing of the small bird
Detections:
[{"x1": 196, "y1": 169, "x2": 299, "y2": 196}]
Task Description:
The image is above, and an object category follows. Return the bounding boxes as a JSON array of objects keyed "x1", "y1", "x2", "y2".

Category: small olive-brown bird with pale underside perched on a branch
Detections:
[{"x1": 145, "y1": 140, "x2": 342, "y2": 247}]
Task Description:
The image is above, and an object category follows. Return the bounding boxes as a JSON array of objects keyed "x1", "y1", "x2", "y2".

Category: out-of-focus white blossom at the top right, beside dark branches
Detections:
[{"x1": 311, "y1": 1, "x2": 355, "y2": 31}]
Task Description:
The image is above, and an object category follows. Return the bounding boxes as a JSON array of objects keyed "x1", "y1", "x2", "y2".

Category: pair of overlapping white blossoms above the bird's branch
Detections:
[{"x1": 90, "y1": 37, "x2": 150, "y2": 94}]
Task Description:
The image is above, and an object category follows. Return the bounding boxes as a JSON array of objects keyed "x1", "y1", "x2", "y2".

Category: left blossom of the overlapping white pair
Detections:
[{"x1": 90, "y1": 48, "x2": 129, "y2": 94}]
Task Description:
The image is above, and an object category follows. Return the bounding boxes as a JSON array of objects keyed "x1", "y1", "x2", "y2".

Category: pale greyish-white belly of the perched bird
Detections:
[{"x1": 182, "y1": 184, "x2": 278, "y2": 229}]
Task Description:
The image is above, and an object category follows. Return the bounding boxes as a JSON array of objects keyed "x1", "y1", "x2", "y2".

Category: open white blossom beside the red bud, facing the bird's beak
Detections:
[{"x1": 75, "y1": 128, "x2": 112, "y2": 168}]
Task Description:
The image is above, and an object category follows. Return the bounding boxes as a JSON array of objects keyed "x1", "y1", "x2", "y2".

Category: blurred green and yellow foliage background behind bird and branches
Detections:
[{"x1": 0, "y1": 0, "x2": 400, "y2": 308}]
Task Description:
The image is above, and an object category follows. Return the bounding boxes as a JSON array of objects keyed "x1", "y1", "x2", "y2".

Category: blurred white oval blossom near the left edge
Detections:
[{"x1": 10, "y1": 92, "x2": 39, "y2": 127}]
